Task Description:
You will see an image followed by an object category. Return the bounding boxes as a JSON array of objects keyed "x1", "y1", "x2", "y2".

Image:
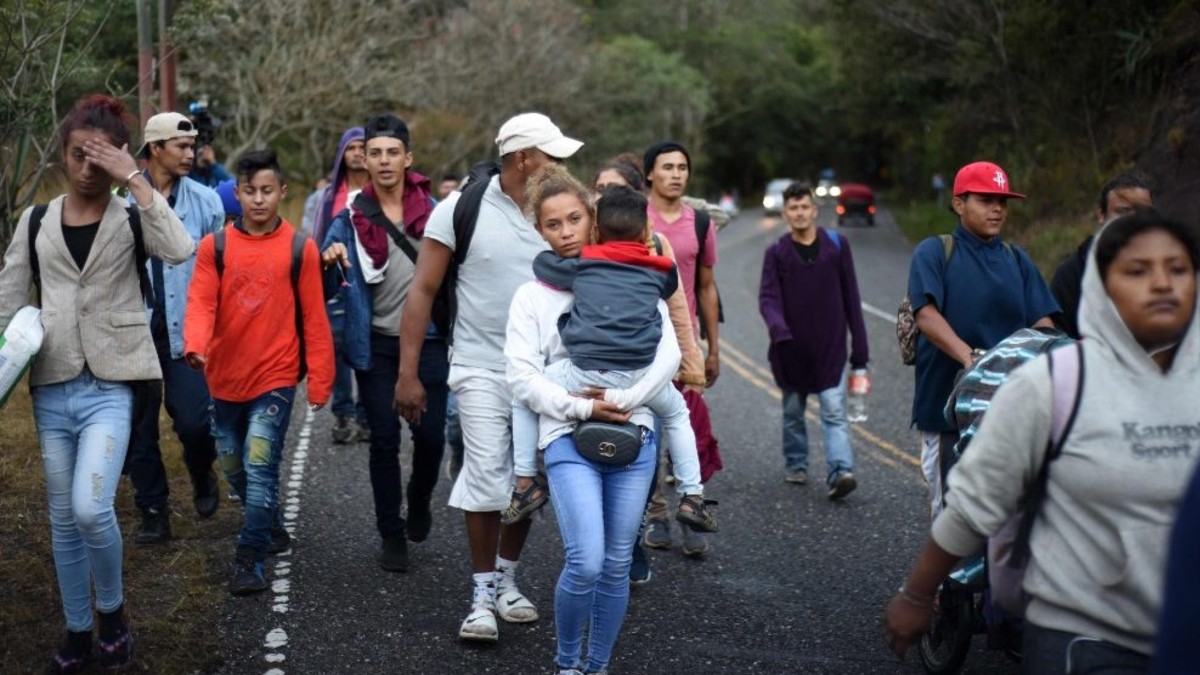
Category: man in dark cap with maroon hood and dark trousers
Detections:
[{"x1": 322, "y1": 114, "x2": 450, "y2": 572}]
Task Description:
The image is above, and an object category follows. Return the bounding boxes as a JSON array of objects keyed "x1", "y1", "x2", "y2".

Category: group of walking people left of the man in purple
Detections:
[{"x1": 0, "y1": 90, "x2": 748, "y2": 673}]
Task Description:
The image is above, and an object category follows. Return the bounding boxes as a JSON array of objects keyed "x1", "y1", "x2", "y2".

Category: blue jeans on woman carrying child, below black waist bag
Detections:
[{"x1": 546, "y1": 434, "x2": 658, "y2": 673}]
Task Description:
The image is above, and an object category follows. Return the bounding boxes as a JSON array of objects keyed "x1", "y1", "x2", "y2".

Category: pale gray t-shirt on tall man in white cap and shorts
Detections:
[{"x1": 425, "y1": 175, "x2": 550, "y2": 372}]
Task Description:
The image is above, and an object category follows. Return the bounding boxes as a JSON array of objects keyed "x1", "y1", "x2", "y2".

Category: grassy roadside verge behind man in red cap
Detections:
[{"x1": 888, "y1": 201, "x2": 1096, "y2": 276}]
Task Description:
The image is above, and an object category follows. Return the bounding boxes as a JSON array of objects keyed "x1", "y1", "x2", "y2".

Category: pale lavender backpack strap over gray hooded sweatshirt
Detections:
[{"x1": 1009, "y1": 342, "x2": 1084, "y2": 567}]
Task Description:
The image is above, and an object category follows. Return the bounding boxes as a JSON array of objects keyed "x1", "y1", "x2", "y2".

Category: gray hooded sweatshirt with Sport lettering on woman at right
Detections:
[{"x1": 931, "y1": 220, "x2": 1200, "y2": 655}]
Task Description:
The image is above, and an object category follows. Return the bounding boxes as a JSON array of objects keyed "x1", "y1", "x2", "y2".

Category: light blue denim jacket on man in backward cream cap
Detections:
[{"x1": 130, "y1": 174, "x2": 224, "y2": 359}]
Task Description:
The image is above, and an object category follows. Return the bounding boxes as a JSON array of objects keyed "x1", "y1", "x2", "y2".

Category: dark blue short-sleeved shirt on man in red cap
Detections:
[{"x1": 908, "y1": 225, "x2": 1060, "y2": 431}]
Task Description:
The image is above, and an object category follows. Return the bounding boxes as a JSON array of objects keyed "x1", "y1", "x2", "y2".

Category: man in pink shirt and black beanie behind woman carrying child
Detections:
[{"x1": 643, "y1": 141, "x2": 721, "y2": 557}]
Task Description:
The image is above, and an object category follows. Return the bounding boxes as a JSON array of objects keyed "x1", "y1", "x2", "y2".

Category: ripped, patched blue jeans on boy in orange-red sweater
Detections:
[{"x1": 212, "y1": 387, "x2": 296, "y2": 562}]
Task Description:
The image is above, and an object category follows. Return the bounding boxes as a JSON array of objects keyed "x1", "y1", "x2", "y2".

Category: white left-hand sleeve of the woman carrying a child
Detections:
[{"x1": 504, "y1": 282, "x2": 592, "y2": 420}]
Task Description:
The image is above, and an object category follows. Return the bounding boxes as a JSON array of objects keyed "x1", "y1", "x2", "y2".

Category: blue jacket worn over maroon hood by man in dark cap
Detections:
[{"x1": 320, "y1": 209, "x2": 438, "y2": 370}]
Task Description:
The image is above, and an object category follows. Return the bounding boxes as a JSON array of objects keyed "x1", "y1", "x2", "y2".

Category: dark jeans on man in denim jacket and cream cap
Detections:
[{"x1": 128, "y1": 336, "x2": 217, "y2": 510}]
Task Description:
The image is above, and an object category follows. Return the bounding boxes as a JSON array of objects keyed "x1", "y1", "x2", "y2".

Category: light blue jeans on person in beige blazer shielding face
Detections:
[{"x1": 34, "y1": 366, "x2": 133, "y2": 632}]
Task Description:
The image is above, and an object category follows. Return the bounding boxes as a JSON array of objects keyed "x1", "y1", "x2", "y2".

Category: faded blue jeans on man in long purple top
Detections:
[{"x1": 784, "y1": 375, "x2": 854, "y2": 483}]
